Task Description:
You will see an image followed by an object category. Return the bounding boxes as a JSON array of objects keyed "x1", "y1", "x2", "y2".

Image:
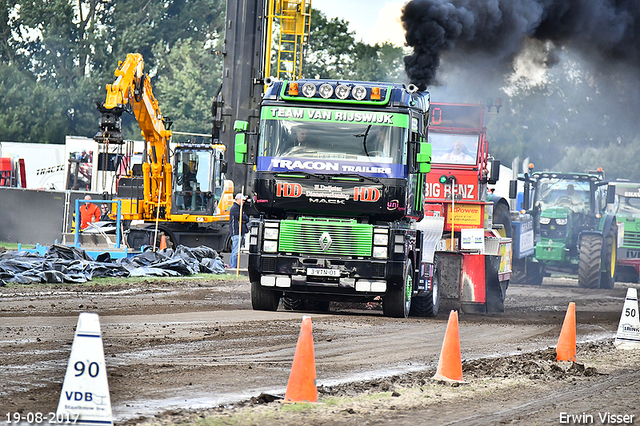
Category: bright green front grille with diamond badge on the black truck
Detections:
[{"x1": 278, "y1": 218, "x2": 373, "y2": 257}]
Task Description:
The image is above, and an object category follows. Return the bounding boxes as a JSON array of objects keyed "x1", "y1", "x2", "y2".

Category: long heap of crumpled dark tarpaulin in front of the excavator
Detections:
[{"x1": 0, "y1": 244, "x2": 224, "y2": 285}]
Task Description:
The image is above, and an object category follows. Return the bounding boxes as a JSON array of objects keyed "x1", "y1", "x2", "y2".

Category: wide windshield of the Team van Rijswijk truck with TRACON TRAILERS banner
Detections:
[{"x1": 258, "y1": 114, "x2": 407, "y2": 177}]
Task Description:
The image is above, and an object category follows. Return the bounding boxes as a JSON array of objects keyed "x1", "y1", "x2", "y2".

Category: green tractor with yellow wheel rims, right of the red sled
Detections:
[{"x1": 524, "y1": 172, "x2": 618, "y2": 288}]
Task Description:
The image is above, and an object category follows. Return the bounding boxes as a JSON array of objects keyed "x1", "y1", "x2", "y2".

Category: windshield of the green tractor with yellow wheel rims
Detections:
[{"x1": 535, "y1": 178, "x2": 590, "y2": 213}]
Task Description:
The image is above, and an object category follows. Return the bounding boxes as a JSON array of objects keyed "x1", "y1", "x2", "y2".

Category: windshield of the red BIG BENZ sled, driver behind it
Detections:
[{"x1": 429, "y1": 132, "x2": 478, "y2": 165}]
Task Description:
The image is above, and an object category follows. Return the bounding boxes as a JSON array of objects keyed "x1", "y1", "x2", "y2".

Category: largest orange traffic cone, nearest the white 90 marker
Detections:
[{"x1": 284, "y1": 316, "x2": 318, "y2": 402}]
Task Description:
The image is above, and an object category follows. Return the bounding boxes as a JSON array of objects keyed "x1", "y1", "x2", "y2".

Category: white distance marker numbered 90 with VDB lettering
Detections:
[{"x1": 56, "y1": 312, "x2": 113, "y2": 426}]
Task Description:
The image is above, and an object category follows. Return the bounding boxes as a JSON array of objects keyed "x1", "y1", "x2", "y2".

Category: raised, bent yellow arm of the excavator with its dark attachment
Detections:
[{"x1": 93, "y1": 53, "x2": 172, "y2": 220}]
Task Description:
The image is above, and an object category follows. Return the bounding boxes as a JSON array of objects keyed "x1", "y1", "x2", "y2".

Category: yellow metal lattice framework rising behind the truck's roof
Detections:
[{"x1": 265, "y1": 0, "x2": 311, "y2": 80}]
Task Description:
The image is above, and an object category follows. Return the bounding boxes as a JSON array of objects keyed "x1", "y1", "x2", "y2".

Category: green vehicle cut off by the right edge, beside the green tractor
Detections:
[{"x1": 609, "y1": 179, "x2": 640, "y2": 283}]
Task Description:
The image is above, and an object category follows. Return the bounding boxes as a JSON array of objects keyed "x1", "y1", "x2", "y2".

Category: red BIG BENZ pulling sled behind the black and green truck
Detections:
[{"x1": 424, "y1": 102, "x2": 516, "y2": 313}]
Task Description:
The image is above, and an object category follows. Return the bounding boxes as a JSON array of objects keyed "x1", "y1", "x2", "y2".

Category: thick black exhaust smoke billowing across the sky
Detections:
[{"x1": 402, "y1": 0, "x2": 640, "y2": 89}]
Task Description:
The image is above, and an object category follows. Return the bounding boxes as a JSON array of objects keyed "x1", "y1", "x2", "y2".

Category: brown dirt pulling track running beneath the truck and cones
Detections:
[{"x1": 0, "y1": 277, "x2": 640, "y2": 425}]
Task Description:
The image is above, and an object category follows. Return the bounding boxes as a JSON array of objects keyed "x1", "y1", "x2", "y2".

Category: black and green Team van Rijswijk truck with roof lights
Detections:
[{"x1": 234, "y1": 79, "x2": 438, "y2": 318}]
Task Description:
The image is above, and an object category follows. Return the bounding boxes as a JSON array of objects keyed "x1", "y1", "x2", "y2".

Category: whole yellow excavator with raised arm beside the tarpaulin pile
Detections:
[{"x1": 93, "y1": 53, "x2": 234, "y2": 251}]
